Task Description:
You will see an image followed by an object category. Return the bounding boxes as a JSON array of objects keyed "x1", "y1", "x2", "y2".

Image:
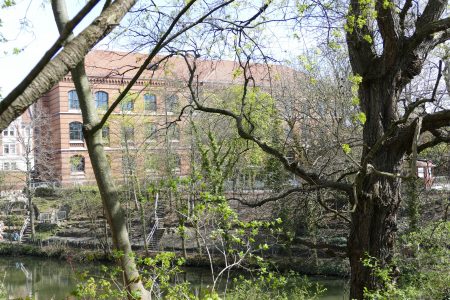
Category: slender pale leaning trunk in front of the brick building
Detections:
[{"x1": 52, "y1": 0, "x2": 151, "y2": 299}]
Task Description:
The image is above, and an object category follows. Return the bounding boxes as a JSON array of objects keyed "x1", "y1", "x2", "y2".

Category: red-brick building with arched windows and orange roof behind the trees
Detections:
[{"x1": 37, "y1": 51, "x2": 282, "y2": 186}]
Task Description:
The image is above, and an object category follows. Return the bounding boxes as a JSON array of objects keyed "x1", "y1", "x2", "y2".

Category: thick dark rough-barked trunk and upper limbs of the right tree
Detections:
[{"x1": 346, "y1": 0, "x2": 450, "y2": 299}]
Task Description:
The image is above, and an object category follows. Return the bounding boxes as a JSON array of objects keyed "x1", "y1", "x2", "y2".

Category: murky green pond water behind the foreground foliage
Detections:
[{"x1": 0, "y1": 257, "x2": 347, "y2": 300}]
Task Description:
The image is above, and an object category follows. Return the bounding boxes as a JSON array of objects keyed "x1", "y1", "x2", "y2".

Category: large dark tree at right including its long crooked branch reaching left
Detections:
[{"x1": 177, "y1": 0, "x2": 450, "y2": 299}]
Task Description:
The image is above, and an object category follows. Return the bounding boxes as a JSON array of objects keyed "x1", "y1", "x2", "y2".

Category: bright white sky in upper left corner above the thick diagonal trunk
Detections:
[{"x1": 0, "y1": 0, "x2": 103, "y2": 97}]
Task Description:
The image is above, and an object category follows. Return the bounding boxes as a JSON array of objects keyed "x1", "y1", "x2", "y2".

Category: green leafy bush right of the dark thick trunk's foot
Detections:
[{"x1": 364, "y1": 221, "x2": 450, "y2": 300}]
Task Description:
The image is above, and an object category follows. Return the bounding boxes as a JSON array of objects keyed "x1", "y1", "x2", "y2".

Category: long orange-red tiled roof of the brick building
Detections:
[{"x1": 72, "y1": 50, "x2": 293, "y2": 86}]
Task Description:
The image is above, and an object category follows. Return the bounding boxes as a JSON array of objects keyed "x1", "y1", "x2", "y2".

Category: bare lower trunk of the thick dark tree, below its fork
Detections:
[{"x1": 348, "y1": 78, "x2": 404, "y2": 299}]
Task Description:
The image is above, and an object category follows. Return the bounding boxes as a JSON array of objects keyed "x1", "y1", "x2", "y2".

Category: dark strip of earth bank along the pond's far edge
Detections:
[{"x1": 0, "y1": 242, "x2": 349, "y2": 278}]
